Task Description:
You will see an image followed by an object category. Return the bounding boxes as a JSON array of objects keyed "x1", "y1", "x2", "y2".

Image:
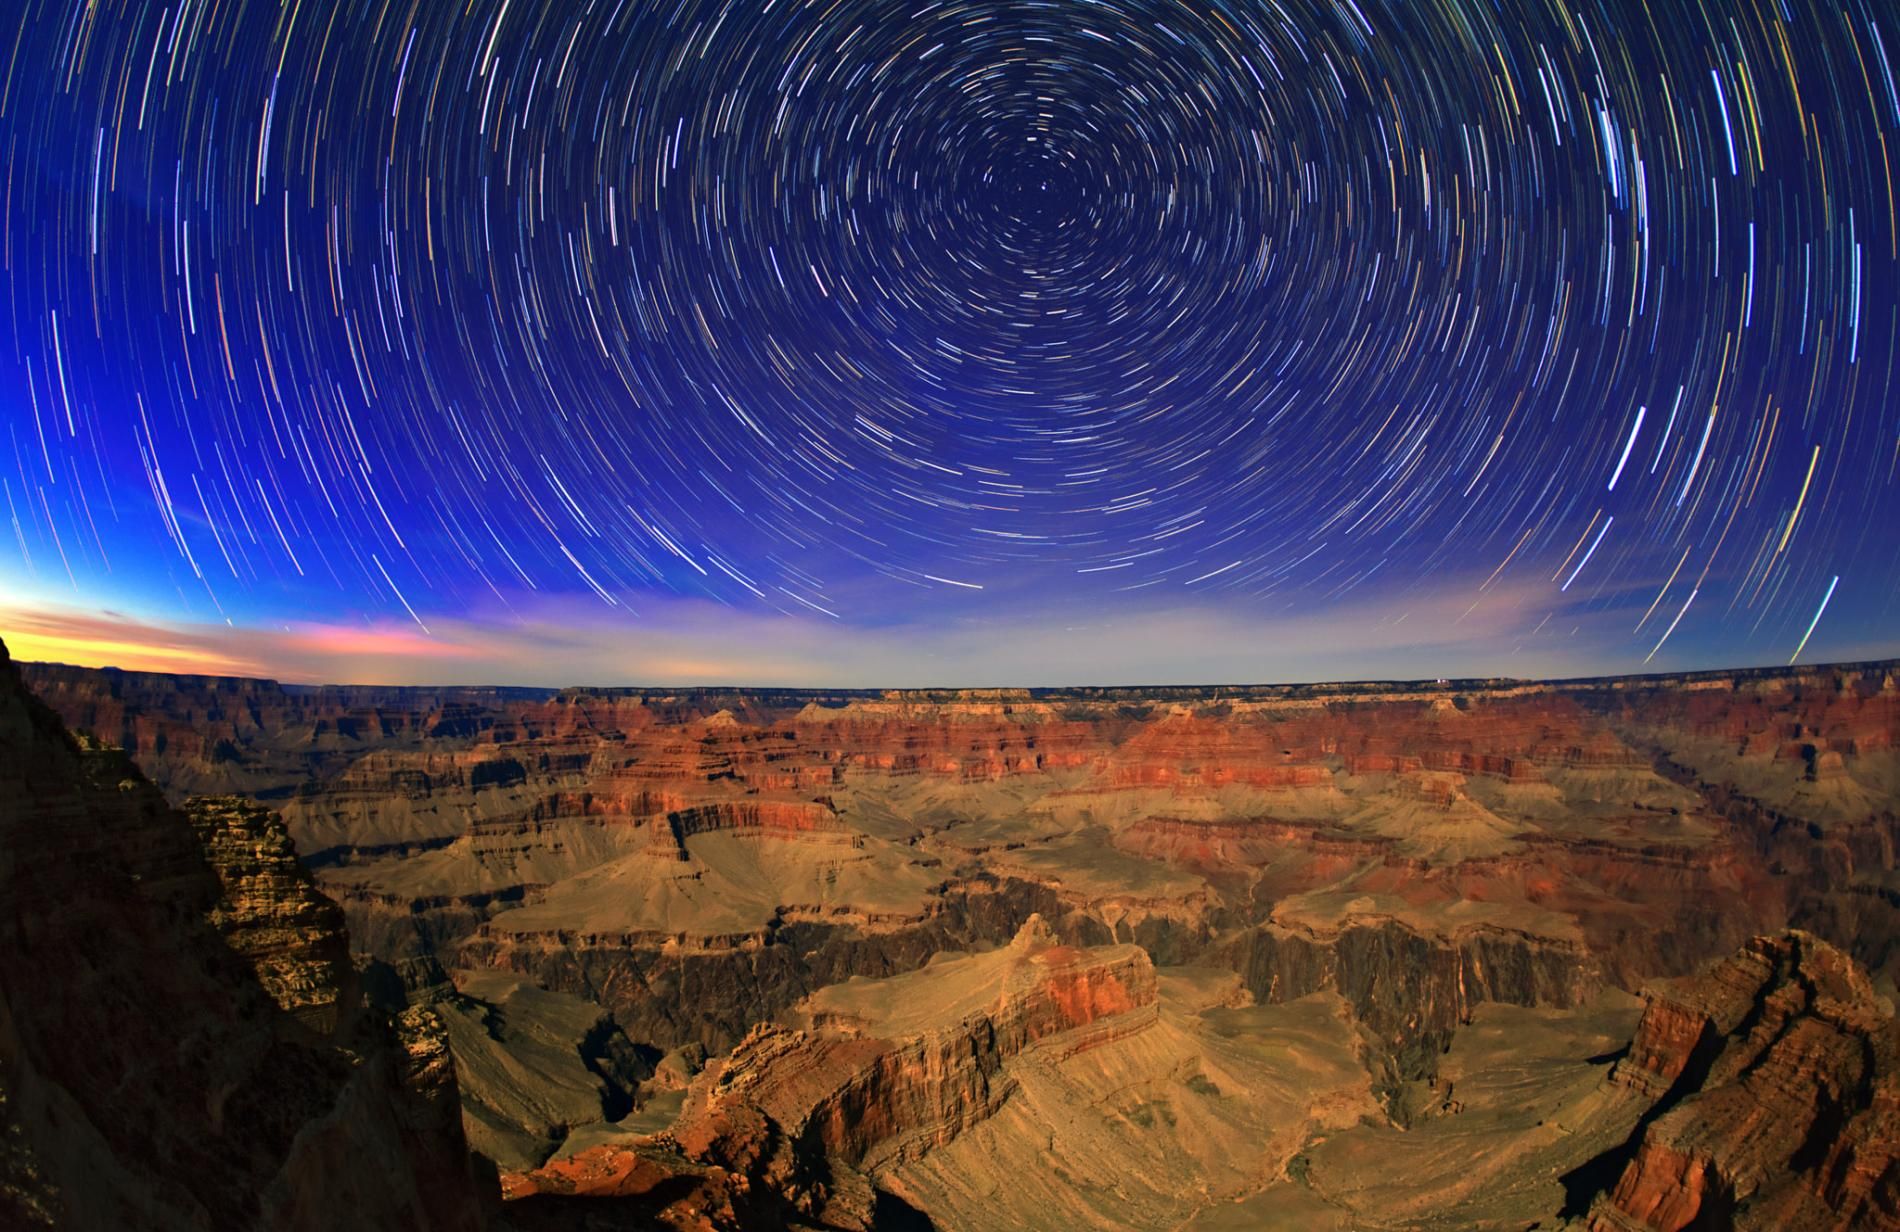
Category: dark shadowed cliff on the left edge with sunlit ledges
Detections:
[{"x1": 0, "y1": 650, "x2": 497, "y2": 1232}]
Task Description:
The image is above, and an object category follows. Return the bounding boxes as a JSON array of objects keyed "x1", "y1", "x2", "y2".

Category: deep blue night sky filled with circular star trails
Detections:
[{"x1": 0, "y1": 0, "x2": 1900, "y2": 684}]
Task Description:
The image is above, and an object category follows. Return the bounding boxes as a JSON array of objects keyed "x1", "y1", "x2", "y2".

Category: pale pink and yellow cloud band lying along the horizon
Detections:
[{"x1": 0, "y1": 578, "x2": 1679, "y2": 686}]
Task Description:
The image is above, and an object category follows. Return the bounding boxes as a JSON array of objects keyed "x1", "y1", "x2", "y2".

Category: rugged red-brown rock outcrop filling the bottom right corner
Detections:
[{"x1": 1588, "y1": 932, "x2": 1900, "y2": 1232}]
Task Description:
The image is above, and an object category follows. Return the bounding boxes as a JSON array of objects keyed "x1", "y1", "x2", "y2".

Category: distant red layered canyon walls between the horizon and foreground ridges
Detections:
[{"x1": 29, "y1": 665, "x2": 1900, "y2": 1102}]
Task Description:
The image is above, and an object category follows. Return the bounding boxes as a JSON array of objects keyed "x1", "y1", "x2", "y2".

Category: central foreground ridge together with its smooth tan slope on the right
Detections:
[{"x1": 504, "y1": 916, "x2": 1378, "y2": 1228}]
